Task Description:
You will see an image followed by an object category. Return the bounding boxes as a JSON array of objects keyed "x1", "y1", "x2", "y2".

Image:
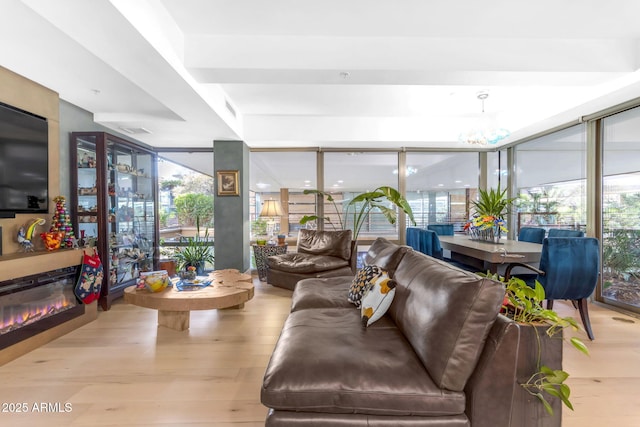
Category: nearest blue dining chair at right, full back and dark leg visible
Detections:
[{"x1": 505, "y1": 237, "x2": 600, "y2": 340}]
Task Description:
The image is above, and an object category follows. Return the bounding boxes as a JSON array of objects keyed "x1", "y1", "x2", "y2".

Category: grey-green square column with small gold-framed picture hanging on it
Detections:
[{"x1": 213, "y1": 141, "x2": 250, "y2": 272}]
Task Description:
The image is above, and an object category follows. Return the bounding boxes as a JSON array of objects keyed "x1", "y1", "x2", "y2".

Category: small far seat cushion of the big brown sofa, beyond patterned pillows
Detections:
[{"x1": 291, "y1": 276, "x2": 356, "y2": 311}]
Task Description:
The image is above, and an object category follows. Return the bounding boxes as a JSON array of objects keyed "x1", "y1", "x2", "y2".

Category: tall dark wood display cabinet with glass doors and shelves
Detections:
[{"x1": 71, "y1": 132, "x2": 158, "y2": 310}]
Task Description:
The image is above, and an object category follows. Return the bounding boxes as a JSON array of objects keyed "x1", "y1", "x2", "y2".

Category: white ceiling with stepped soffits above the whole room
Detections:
[{"x1": 0, "y1": 0, "x2": 640, "y2": 154}]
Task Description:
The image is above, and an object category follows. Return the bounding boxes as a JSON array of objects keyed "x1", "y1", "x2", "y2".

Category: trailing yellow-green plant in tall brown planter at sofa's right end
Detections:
[{"x1": 487, "y1": 274, "x2": 589, "y2": 426}]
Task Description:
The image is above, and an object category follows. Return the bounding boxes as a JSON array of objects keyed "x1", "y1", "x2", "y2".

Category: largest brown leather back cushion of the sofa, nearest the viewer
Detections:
[{"x1": 388, "y1": 251, "x2": 505, "y2": 391}]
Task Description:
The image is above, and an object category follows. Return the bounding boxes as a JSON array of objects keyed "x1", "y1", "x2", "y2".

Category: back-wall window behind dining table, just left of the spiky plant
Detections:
[{"x1": 407, "y1": 152, "x2": 478, "y2": 231}]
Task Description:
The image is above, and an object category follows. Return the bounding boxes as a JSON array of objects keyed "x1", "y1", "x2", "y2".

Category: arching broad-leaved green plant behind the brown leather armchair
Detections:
[{"x1": 300, "y1": 186, "x2": 416, "y2": 241}]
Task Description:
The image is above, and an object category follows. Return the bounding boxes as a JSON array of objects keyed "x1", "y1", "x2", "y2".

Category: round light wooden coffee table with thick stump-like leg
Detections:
[{"x1": 124, "y1": 269, "x2": 253, "y2": 331}]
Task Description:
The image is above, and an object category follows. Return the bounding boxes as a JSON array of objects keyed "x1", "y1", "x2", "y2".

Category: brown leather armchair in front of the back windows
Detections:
[{"x1": 267, "y1": 230, "x2": 357, "y2": 290}]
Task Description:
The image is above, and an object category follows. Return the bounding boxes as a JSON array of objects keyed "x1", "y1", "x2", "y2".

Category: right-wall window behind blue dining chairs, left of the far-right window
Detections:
[{"x1": 512, "y1": 125, "x2": 587, "y2": 235}]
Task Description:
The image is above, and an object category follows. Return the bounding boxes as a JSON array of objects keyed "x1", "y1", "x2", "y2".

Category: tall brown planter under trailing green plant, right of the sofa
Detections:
[{"x1": 510, "y1": 324, "x2": 563, "y2": 427}]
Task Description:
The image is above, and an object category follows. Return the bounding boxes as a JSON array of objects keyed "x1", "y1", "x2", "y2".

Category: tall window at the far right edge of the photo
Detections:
[{"x1": 602, "y1": 108, "x2": 640, "y2": 312}]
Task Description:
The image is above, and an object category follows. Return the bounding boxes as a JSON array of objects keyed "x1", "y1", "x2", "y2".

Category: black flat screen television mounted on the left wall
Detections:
[{"x1": 0, "y1": 103, "x2": 49, "y2": 217}]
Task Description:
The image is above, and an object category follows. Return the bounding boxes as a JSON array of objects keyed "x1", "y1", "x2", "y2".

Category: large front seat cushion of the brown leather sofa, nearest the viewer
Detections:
[{"x1": 261, "y1": 308, "x2": 465, "y2": 416}]
